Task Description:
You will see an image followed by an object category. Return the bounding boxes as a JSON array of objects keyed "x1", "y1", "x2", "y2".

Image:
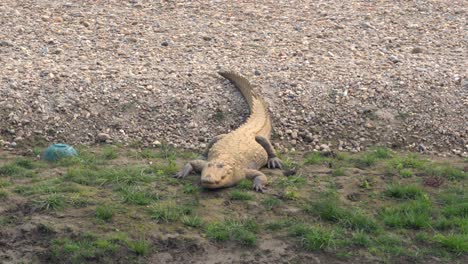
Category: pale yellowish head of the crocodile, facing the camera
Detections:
[{"x1": 201, "y1": 161, "x2": 233, "y2": 189}]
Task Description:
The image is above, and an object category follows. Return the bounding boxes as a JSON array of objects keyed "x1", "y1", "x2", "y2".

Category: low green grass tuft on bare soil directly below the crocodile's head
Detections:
[{"x1": 205, "y1": 219, "x2": 259, "y2": 246}]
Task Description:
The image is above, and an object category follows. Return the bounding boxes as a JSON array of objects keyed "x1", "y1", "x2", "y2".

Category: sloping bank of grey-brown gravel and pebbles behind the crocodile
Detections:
[{"x1": 0, "y1": 0, "x2": 462, "y2": 155}]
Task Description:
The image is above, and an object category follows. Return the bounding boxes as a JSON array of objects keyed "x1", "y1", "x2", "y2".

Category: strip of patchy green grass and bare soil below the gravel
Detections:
[{"x1": 0, "y1": 145, "x2": 468, "y2": 263}]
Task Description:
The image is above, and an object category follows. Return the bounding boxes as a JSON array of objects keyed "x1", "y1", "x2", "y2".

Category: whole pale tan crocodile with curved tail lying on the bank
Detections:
[{"x1": 175, "y1": 72, "x2": 282, "y2": 192}]
